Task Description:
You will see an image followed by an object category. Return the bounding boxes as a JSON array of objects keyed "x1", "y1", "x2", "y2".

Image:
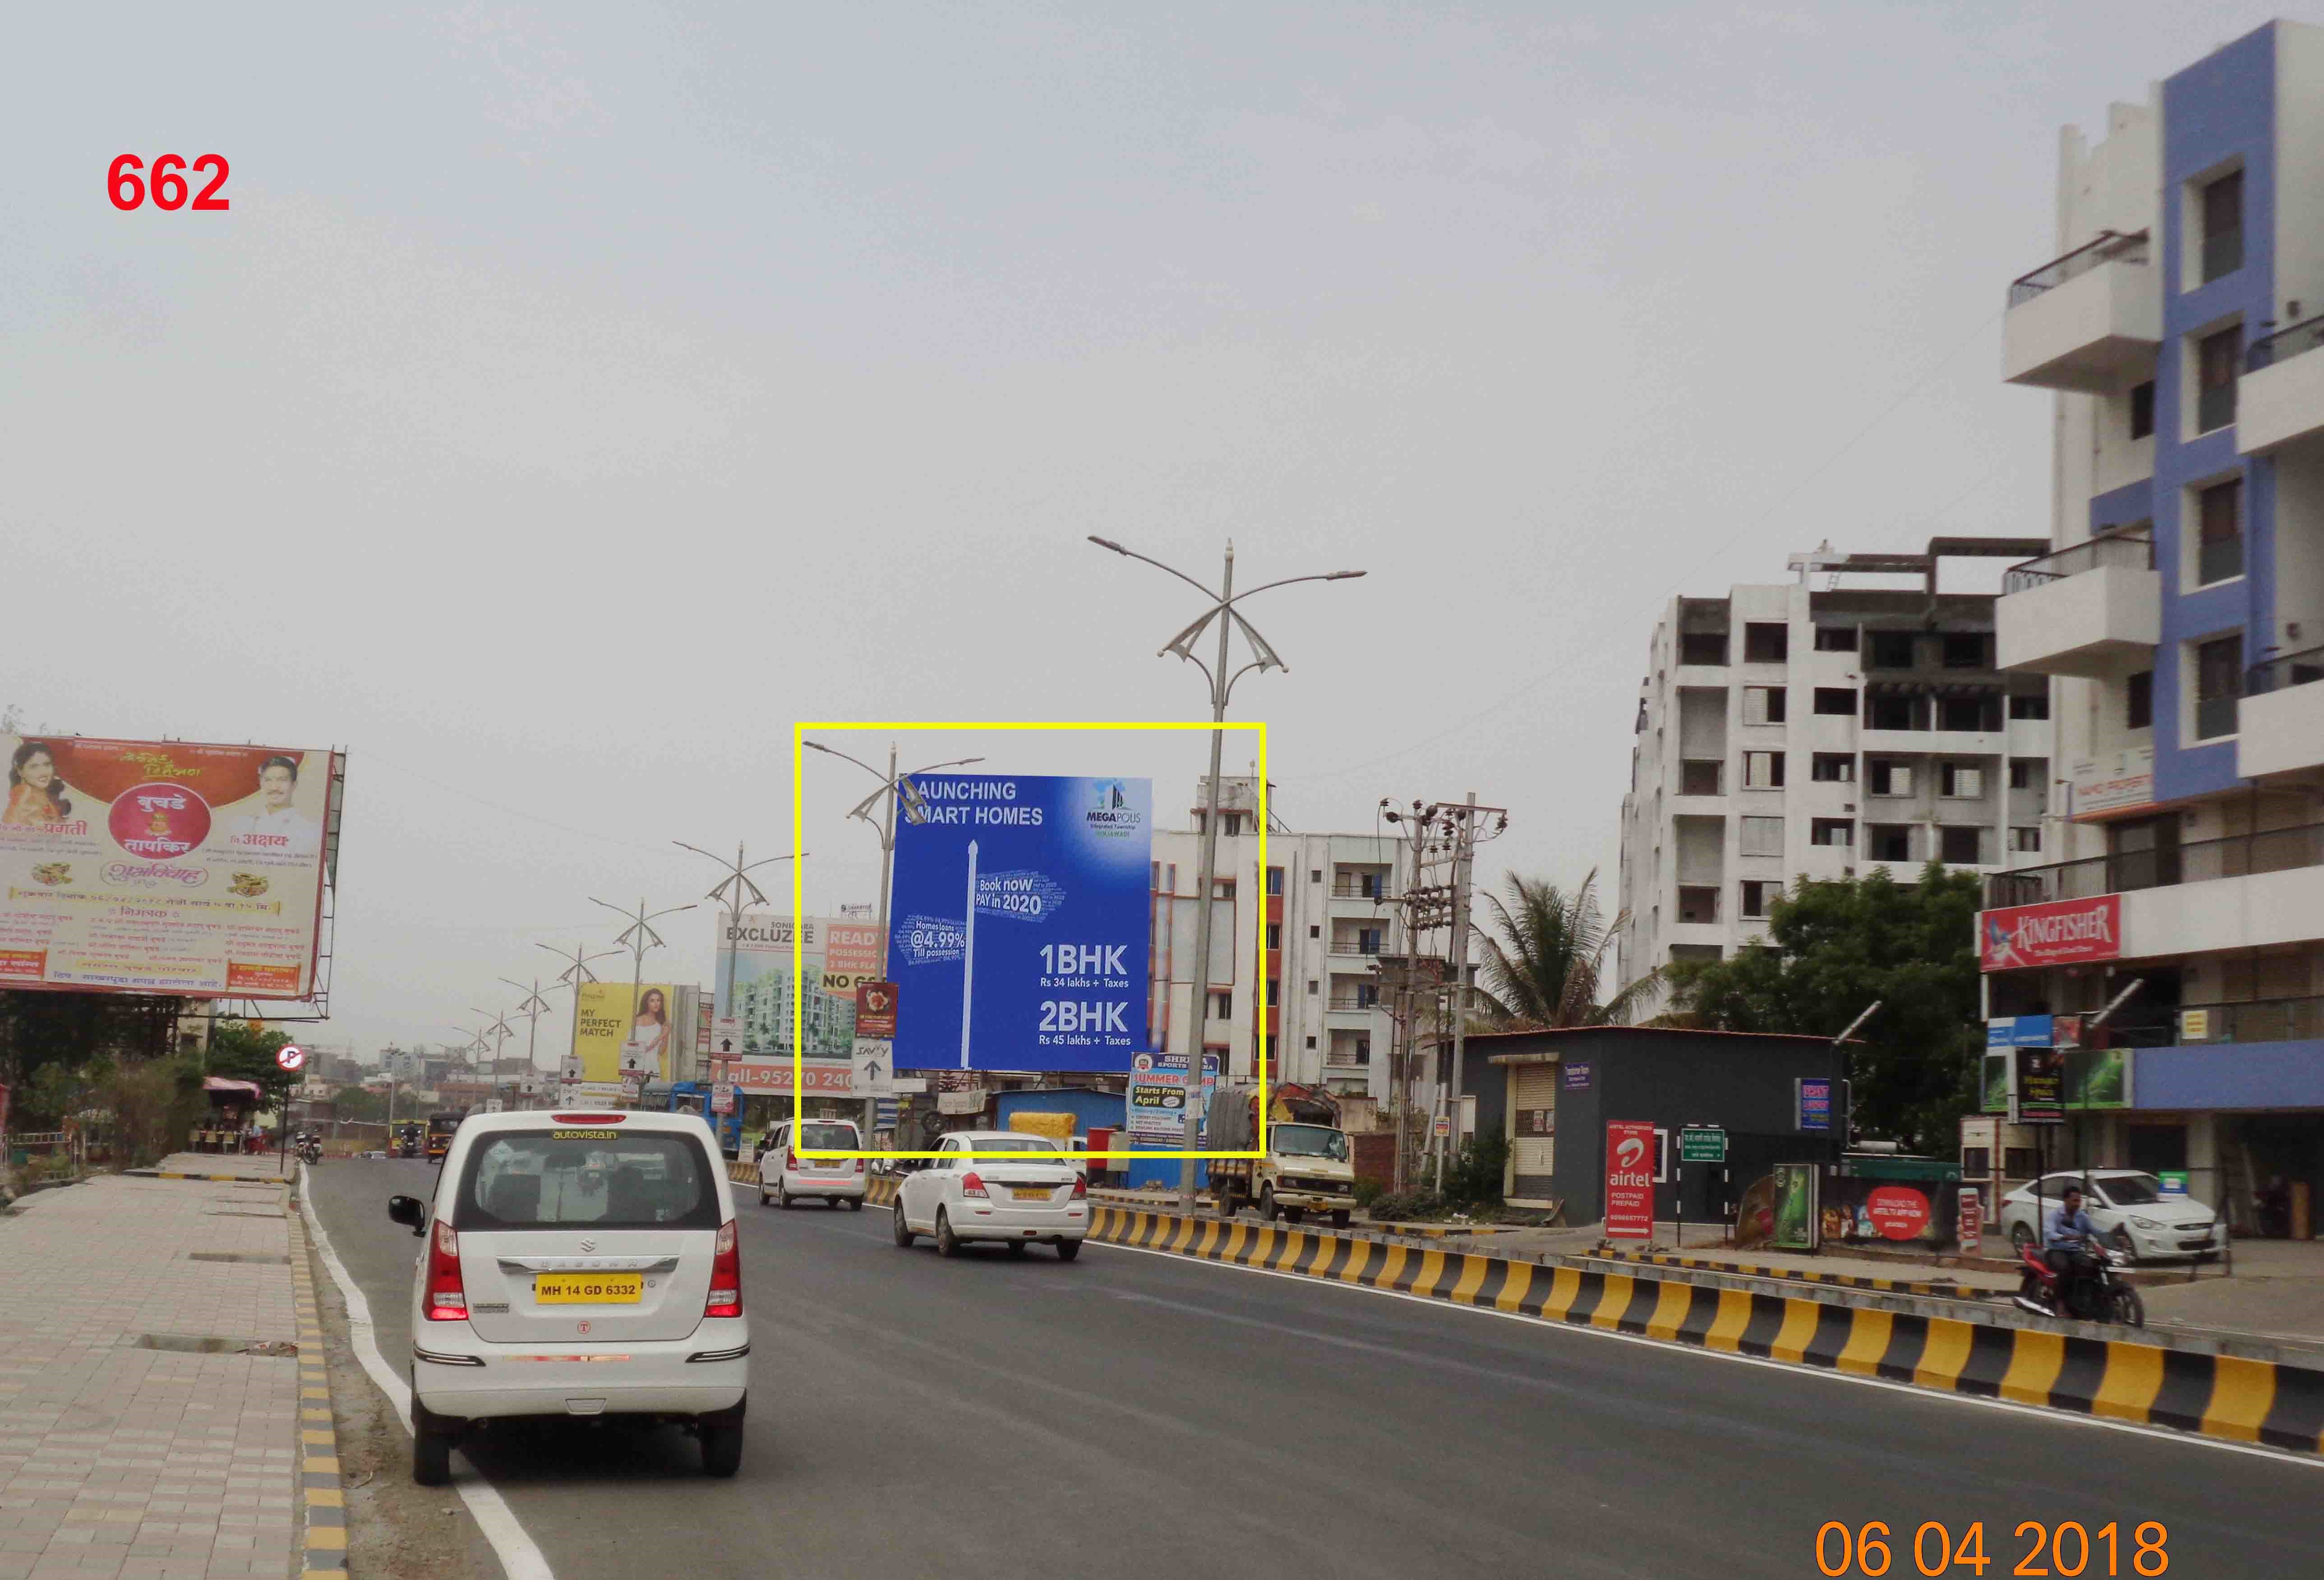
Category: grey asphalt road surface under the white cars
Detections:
[{"x1": 314, "y1": 1162, "x2": 2324, "y2": 1580}]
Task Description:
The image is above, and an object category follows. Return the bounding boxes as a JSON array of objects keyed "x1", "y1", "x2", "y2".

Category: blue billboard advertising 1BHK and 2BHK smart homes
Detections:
[{"x1": 888, "y1": 774, "x2": 1153, "y2": 1071}]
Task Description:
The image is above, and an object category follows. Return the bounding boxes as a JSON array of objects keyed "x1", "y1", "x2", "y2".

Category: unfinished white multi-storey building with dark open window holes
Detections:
[{"x1": 1618, "y1": 548, "x2": 2052, "y2": 980}]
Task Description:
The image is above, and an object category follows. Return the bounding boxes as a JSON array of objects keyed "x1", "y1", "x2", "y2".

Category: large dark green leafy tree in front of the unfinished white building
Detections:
[{"x1": 1666, "y1": 862, "x2": 1983, "y2": 1152}]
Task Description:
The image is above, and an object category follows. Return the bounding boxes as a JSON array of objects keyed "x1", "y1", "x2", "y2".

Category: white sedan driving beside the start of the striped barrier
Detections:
[{"x1": 895, "y1": 1129, "x2": 1090, "y2": 1261}]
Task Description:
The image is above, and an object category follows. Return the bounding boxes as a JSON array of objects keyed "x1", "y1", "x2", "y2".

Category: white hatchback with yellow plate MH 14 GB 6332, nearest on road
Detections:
[{"x1": 388, "y1": 1111, "x2": 751, "y2": 1487}]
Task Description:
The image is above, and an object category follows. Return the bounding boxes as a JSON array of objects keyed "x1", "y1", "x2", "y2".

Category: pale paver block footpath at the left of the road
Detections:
[{"x1": 0, "y1": 1157, "x2": 300, "y2": 1580}]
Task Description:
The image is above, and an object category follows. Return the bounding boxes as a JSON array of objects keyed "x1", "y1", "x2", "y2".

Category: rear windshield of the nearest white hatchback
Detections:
[{"x1": 453, "y1": 1127, "x2": 718, "y2": 1229}]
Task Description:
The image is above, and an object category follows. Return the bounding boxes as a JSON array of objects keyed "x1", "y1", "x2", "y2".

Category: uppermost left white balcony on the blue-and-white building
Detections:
[{"x1": 2001, "y1": 230, "x2": 2164, "y2": 393}]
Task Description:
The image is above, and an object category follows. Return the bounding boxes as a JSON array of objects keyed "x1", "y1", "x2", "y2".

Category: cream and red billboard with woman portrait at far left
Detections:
[{"x1": 0, "y1": 734, "x2": 346, "y2": 999}]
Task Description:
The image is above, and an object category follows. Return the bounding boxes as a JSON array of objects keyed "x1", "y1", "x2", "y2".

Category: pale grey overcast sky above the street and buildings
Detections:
[{"x1": 0, "y1": 0, "x2": 2271, "y2": 1057}]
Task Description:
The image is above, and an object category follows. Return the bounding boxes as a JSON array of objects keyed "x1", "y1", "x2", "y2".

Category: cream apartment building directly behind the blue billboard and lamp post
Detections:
[{"x1": 1148, "y1": 778, "x2": 1406, "y2": 1101}]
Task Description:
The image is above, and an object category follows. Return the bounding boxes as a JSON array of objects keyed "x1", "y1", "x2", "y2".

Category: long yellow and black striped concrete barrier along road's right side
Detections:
[{"x1": 1090, "y1": 1206, "x2": 2324, "y2": 1455}]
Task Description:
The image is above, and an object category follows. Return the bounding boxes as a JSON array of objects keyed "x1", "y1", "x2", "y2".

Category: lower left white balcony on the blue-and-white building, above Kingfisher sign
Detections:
[{"x1": 1994, "y1": 532, "x2": 2164, "y2": 679}]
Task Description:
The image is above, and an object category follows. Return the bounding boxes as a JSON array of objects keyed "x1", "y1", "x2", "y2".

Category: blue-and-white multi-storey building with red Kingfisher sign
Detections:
[{"x1": 1980, "y1": 21, "x2": 2324, "y2": 1224}]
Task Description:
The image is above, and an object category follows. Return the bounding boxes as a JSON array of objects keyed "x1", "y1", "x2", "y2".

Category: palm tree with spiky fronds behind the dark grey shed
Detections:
[{"x1": 1478, "y1": 867, "x2": 1662, "y2": 1029}]
